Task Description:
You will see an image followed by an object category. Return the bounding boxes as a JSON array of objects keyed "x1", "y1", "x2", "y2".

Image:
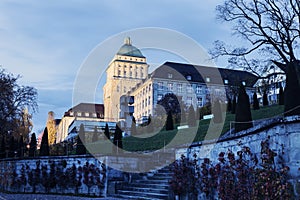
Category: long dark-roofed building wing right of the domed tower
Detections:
[{"x1": 130, "y1": 62, "x2": 258, "y2": 119}]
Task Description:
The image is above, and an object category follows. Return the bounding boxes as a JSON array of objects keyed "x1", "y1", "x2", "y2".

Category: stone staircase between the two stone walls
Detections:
[{"x1": 115, "y1": 166, "x2": 172, "y2": 200}]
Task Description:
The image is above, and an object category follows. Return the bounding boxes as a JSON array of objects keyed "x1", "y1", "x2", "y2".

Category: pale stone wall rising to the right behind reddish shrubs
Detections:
[{"x1": 176, "y1": 116, "x2": 300, "y2": 197}]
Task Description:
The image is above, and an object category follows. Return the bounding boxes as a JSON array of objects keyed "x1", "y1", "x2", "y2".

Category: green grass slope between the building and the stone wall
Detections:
[{"x1": 88, "y1": 105, "x2": 284, "y2": 153}]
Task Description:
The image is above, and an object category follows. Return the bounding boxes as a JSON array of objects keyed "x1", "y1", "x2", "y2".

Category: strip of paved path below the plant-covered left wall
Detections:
[{"x1": 0, "y1": 193, "x2": 120, "y2": 200}]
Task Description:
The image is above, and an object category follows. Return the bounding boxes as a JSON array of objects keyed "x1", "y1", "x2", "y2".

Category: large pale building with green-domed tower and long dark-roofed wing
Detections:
[{"x1": 103, "y1": 38, "x2": 258, "y2": 130}]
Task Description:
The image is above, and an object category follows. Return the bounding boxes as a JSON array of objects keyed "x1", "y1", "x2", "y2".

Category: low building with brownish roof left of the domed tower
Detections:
[{"x1": 56, "y1": 103, "x2": 105, "y2": 143}]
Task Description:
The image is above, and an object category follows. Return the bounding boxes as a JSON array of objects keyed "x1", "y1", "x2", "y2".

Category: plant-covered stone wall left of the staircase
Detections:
[{"x1": 0, "y1": 156, "x2": 107, "y2": 196}]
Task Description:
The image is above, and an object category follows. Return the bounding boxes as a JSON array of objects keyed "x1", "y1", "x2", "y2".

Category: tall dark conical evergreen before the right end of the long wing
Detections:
[{"x1": 235, "y1": 85, "x2": 253, "y2": 132}]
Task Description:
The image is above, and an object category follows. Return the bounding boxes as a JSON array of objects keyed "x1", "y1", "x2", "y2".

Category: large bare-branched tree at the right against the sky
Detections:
[{"x1": 210, "y1": 0, "x2": 300, "y2": 115}]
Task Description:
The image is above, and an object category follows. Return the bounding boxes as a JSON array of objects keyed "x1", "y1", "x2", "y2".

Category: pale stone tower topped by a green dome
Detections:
[{"x1": 103, "y1": 37, "x2": 149, "y2": 121}]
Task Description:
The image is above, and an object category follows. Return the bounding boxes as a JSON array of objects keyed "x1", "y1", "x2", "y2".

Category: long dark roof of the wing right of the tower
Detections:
[{"x1": 151, "y1": 62, "x2": 258, "y2": 87}]
